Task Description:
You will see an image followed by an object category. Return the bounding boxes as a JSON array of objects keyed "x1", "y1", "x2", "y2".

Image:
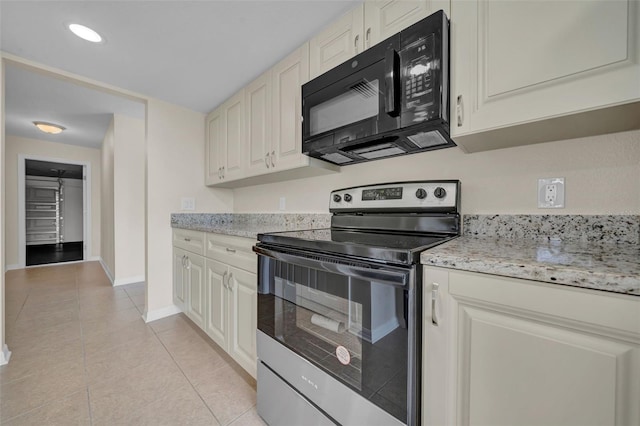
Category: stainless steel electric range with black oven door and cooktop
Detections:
[{"x1": 254, "y1": 180, "x2": 460, "y2": 426}]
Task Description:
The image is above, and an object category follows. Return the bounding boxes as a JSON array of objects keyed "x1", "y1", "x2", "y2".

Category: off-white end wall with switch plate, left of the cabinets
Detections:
[{"x1": 145, "y1": 100, "x2": 233, "y2": 321}]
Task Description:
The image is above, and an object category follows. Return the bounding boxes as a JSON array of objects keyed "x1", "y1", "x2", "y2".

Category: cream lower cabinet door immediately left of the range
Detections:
[{"x1": 229, "y1": 267, "x2": 257, "y2": 377}]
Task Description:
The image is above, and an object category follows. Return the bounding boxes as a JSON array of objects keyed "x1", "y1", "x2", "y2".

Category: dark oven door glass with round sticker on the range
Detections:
[{"x1": 258, "y1": 257, "x2": 408, "y2": 422}]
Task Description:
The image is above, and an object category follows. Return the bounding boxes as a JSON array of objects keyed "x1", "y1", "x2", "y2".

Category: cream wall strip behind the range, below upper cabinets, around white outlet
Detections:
[{"x1": 234, "y1": 131, "x2": 640, "y2": 214}]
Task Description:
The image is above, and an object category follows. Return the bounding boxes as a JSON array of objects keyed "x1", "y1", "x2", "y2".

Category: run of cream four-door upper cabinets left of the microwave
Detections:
[{"x1": 206, "y1": 43, "x2": 340, "y2": 188}]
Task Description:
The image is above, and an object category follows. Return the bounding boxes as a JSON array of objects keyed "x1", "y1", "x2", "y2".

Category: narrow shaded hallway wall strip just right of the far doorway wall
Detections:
[{"x1": 100, "y1": 119, "x2": 116, "y2": 281}]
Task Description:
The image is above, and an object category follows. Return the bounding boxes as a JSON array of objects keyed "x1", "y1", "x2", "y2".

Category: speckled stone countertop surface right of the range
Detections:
[{"x1": 421, "y1": 236, "x2": 640, "y2": 296}]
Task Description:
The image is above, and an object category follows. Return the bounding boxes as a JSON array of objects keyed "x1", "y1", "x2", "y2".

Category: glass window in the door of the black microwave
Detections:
[{"x1": 309, "y1": 79, "x2": 380, "y2": 136}]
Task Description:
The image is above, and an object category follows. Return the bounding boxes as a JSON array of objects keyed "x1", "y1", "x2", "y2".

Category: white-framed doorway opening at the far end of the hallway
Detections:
[{"x1": 18, "y1": 156, "x2": 89, "y2": 266}]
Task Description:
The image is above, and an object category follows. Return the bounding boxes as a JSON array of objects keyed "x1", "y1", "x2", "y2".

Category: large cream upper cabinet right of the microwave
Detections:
[{"x1": 450, "y1": 0, "x2": 640, "y2": 152}]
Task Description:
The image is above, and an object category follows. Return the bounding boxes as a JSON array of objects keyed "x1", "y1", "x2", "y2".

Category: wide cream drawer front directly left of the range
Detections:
[{"x1": 205, "y1": 234, "x2": 258, "y2": 274}]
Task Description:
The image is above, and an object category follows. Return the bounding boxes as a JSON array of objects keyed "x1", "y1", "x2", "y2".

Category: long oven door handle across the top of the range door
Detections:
[{"x1": 253, "y1": 246, "x2": 409, "y2": 287}]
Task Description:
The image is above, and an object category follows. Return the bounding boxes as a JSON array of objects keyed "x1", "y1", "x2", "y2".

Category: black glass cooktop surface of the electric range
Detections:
[{"x1": 258, "y1": 228, "x2": 455, "y2": 264}]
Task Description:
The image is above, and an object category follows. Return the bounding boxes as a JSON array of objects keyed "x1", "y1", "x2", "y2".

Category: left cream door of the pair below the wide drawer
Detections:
[{"x1": 204, "y1": 259, "x2": 229, "y2": 350}]
